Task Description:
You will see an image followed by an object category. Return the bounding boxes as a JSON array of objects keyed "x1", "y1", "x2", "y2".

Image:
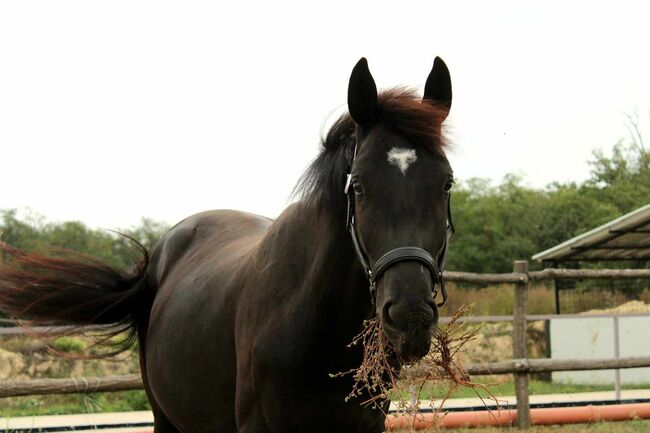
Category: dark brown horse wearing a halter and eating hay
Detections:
[{"x1": 0, "y1": 57, "x2": 453, "y2": 433}]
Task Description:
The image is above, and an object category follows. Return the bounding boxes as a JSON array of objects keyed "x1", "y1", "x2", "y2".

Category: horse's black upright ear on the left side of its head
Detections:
[{"x1": 348, "y1": 57, "x2": 377, "y2": 126}]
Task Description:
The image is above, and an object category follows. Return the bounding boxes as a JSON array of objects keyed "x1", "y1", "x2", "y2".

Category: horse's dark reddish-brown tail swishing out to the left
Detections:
[{"x1": 0, "y1": 238, "x2": 151, "y2": 351}]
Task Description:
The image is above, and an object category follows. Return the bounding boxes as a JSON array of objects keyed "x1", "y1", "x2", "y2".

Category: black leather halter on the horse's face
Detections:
[{"x1": 344, "y1": 132, "x2": 455, "y2": 307}]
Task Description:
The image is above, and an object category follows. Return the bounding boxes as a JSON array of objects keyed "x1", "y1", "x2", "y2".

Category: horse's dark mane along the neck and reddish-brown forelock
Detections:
[{"x1": 292, "y1": 87, "x2": 446, "y2": 211}]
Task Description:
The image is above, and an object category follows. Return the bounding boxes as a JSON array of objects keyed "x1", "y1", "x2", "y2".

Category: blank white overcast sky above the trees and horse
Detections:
[{"x1": 0, "y1": 0, "x2": 650, "y2": 229}]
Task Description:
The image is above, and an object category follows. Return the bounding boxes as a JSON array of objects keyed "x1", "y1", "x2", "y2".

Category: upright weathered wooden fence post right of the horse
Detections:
[{"x1": 512, "y1": 260, "x2": 530, "y2": 429}]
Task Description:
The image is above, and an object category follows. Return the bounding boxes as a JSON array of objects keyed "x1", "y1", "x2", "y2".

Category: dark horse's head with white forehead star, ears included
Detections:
[{"x1": 346, "y1": 58, "x2": 453, "y2": 361}]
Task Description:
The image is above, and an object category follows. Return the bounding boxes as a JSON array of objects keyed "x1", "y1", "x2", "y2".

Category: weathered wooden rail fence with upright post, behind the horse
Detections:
[{"x1": 0, "y1": 261, "x2": 650, "y2": 428}]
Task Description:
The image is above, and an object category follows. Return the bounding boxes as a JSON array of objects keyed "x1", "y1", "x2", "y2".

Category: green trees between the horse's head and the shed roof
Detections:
[{"x1": 448, "y1": 138, "x2": 650, "y2": 272}]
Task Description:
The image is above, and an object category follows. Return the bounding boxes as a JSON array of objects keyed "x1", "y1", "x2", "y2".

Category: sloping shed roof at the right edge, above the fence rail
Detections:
[{"x1": 533, "y1": 204, "x2": 650, "y2": 262}]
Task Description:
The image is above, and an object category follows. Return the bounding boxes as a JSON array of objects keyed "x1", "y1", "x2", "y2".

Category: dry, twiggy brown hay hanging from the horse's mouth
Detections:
[{"x1": 330, "y1": 305, "x2": 499, "y2": 426}]
